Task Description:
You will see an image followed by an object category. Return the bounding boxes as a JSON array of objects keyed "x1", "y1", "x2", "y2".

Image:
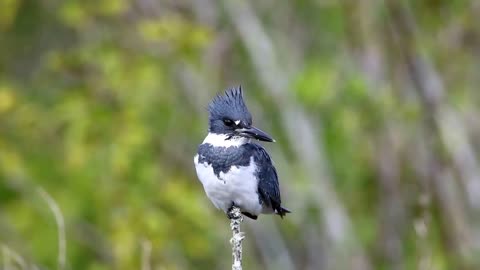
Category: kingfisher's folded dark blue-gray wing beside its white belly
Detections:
[{"x1": 253, "y1": 144, "x2": 290, "y2": 217}]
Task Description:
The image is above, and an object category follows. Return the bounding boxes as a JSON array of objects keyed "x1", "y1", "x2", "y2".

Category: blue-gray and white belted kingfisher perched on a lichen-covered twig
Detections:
[{"x1": 194, "y1": 86, "x2": 290, "y2": 219}]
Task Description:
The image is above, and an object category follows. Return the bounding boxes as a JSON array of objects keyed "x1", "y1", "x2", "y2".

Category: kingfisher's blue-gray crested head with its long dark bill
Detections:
[{"x1": 208, "y1": 86, "x2": 274, "y2": 142}]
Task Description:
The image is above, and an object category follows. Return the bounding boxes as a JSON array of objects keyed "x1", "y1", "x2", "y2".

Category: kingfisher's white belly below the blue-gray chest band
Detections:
[{"x1": 194, "y1": 155, "x2": 262, "y2": 215}]
